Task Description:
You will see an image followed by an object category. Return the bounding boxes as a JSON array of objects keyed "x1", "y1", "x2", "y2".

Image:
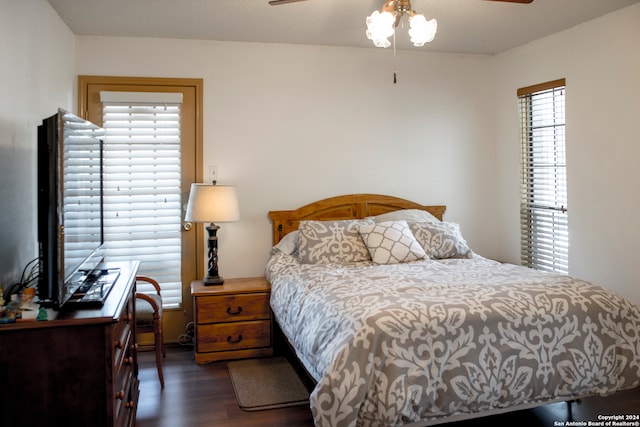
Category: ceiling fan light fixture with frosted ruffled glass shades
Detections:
[{"x1": 366, "y1": 0, "x2": 438, "y2": 47}]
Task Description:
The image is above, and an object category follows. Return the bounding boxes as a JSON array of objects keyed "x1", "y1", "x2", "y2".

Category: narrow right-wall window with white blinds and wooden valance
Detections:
[{"x1": 518, "y1": 79, "x2": 569, "y2": 274}]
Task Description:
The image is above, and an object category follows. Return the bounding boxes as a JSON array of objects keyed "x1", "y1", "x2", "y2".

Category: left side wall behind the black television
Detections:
[{"x1": 0, "y1": 0, "x2": 75, "y2": 286}]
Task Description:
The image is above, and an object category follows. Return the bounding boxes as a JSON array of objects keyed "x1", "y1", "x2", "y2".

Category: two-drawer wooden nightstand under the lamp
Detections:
[{"x1": 191, "y1": 277, "x2": 273, "y2": 363}]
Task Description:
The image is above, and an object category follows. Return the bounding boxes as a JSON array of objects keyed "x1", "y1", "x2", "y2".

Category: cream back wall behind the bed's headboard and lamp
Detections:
[{"x1": 76, "y1": 37, "x2": 496, "y2": 277}]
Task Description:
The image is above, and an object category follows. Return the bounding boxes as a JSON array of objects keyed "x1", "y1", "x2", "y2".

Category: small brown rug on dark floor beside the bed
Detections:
[{"x1": 227, "y1": 357, "x2": 309, "y2": 411}]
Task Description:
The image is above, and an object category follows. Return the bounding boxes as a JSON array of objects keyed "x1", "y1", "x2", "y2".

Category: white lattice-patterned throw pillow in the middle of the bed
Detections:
[{"x1": 360, "y1": 221, "x2": 427, "y2": 264}]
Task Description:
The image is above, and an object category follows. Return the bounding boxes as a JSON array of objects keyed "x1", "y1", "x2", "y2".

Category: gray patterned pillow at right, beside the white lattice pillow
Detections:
[{"x1": 410, "y1": 222, "x2": 473, "y2": 259}]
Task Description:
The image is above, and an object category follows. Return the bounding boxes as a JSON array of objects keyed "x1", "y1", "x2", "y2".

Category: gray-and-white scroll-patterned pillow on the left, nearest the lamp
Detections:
[{"x1": 298, "y1": 219, "x2": 373, "y2": 264}]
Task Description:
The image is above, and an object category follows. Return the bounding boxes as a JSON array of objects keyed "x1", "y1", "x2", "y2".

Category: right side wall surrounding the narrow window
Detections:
[{"x1": 494, "y1": 4, "x2": 640, "y2": 302}]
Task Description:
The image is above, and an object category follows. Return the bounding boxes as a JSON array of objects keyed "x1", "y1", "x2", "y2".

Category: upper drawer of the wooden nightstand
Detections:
[{"x1": 196, "y1": 293, "x2": 271, "y2": 325}]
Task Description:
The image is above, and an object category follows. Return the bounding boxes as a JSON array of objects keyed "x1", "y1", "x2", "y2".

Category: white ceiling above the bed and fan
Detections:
[{"x1": 48, "y1": 0, "x2": 640, "y2": 54}]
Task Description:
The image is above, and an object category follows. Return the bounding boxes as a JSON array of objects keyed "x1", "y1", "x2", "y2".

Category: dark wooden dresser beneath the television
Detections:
[{"x1": 0, "y1": 262, "x2": 139, "y2": 427}]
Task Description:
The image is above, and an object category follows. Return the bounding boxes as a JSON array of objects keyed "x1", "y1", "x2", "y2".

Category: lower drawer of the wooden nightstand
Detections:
[{"x1": 196, "y1": 320, "x2": 271, "y2": 352}]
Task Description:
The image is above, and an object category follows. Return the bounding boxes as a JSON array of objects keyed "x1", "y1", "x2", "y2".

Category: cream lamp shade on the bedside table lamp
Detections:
[{"x1": 184, "y1": 183, "x2": 240, "y2": 222}]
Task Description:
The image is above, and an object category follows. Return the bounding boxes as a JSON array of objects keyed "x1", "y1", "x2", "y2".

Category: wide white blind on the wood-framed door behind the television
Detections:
[{"x1": 100, "y1": 92, "x2": 182, "y2": 308}]
